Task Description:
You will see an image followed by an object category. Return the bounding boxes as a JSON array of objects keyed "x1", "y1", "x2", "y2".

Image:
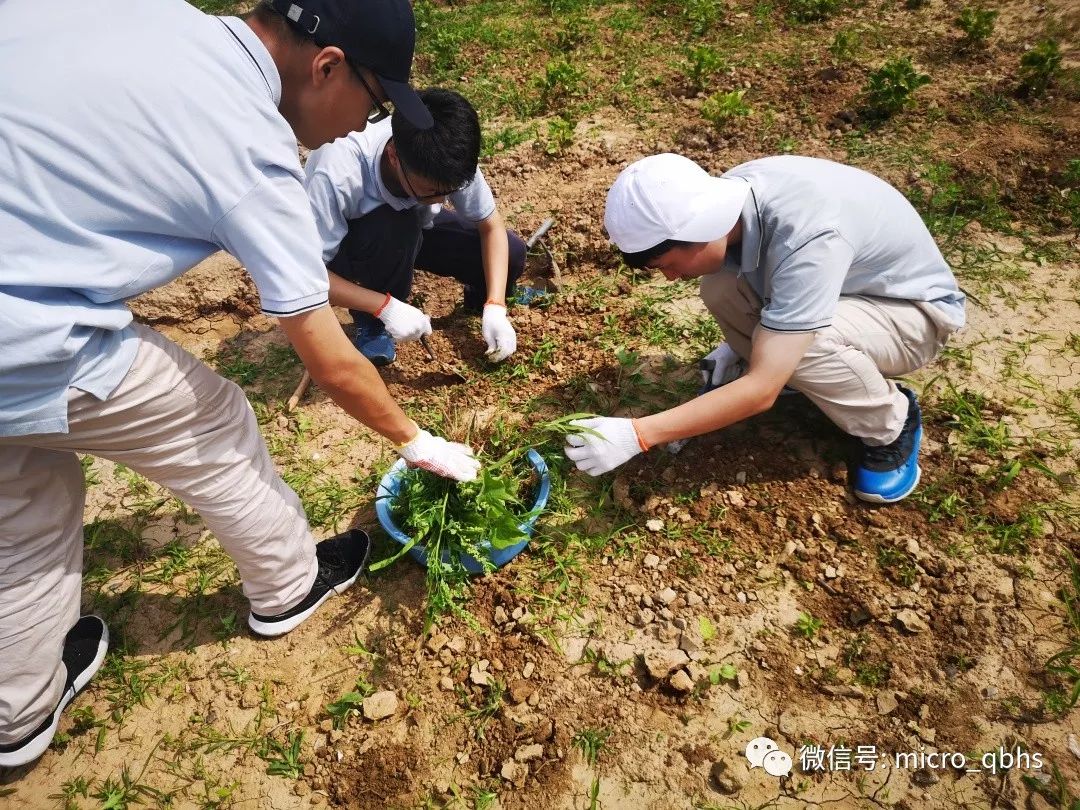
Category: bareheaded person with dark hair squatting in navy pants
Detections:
[{"x1": 305, "y1": 89, "x2": 537, "y2": 366}]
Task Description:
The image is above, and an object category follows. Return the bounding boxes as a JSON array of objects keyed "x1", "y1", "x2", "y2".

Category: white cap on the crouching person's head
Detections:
[{"x1": 604, "y1": 152, "x2": 750, "y2": 253}]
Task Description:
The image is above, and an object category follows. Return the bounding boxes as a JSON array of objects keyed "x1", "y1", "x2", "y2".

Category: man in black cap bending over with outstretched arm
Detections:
[{"x1": 0, "y1": 0, "x2": 478, "y2": 767}]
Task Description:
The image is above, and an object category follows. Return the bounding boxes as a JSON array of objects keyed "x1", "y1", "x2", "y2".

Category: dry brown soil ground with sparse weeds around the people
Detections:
[{"x1": 0, "y1": 0, "x2": 1080, "y2": 810}]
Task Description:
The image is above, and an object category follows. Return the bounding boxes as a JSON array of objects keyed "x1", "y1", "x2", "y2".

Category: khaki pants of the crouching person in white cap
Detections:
[{"x1": 701, "y1": 271, "x2": 949, "y2": 445}]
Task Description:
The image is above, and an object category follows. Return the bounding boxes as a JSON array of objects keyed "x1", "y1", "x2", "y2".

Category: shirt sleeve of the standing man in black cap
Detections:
[{"x1": 212, "y1": 168, "x2": 329, "y2": 318}]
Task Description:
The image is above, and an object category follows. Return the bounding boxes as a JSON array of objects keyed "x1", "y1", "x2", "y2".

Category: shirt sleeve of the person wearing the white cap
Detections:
[{"x1": 761, "y1": 231, "x2": 855, "y2": 332}]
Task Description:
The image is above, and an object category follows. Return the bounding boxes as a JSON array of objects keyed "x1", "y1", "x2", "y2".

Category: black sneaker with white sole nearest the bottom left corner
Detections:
[{"x1": 0, "y1": 616, "x2": 109, "y2": 768}]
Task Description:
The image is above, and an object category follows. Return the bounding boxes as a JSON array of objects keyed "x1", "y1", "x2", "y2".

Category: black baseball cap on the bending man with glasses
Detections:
[{"x1": 269, "y1": 0, "x2": 434, "y2": 130}]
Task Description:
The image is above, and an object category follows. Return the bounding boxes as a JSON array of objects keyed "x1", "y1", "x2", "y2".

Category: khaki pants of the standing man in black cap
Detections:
[{"x1": 0, "y1": 326, "x2": 318, "y2": 744}]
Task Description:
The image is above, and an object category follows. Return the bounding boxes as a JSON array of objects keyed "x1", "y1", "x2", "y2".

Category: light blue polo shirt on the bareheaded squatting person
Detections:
[{"x1": 303, "y1": 119, "x2": 495, "y2": 261}]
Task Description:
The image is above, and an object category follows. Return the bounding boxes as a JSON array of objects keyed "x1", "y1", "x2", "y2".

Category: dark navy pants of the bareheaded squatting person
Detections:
[{"x1": 328, "y1": 205, "x2": 526, "y2": 319}]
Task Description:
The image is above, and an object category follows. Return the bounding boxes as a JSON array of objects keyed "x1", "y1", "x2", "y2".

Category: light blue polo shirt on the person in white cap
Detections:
[{"x1": 723, "y1": 154, "x2": 964, "y2": 332}]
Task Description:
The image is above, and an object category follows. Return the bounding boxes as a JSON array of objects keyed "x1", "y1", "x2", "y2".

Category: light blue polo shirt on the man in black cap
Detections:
[{"x1": 0, "y1": 0, "x2": 328, "y2": 435}]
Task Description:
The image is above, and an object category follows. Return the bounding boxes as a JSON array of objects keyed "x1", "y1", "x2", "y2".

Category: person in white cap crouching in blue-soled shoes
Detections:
[{"x1": 565, "y1": 154, "x2": 964, "y2": 503}]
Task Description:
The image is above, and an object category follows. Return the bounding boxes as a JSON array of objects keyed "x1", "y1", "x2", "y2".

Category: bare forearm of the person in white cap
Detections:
[{"x1": 634, "y1": 377, "x2": 775, "y2": 447}]
